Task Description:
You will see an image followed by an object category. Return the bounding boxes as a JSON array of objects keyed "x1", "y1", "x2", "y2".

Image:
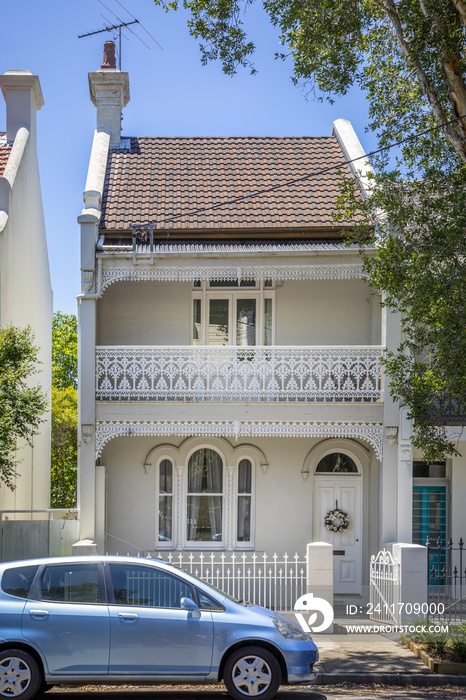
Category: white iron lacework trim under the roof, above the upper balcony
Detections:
[{"x1": 102, "y1": 264, "x2": 364, "y2": 292}]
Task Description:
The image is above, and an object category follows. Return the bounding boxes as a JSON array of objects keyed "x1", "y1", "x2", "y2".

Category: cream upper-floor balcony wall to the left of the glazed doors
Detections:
[{"x1": 97, "y1": 282, "x2": 192, "y2": 345}]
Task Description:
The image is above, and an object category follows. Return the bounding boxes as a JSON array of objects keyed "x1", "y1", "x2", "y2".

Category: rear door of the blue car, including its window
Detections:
[{"x1": 22, "y1": 562, "x2": 110, "y2": 676}]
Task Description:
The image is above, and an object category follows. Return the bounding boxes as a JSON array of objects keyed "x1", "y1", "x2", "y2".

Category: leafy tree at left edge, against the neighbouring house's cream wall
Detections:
[{"x1": 0, "y1": 326, "x2": 47, "y2": 491}]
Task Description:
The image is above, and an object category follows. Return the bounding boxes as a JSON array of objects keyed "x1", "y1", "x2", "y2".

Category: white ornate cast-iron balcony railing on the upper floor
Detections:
[{"x1": 96, "y1": 346, "x2": 383, "y2": 402}]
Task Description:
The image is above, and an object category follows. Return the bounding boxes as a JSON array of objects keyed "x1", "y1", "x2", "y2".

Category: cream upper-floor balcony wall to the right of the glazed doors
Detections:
[{"x1": 276, "y1": 280, "x2": 381, "y2": 345}]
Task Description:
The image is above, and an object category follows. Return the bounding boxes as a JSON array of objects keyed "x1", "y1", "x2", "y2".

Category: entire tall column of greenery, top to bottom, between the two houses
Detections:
[{"x1": 51, "y1": 311, "x2": 78, "y2": 508}]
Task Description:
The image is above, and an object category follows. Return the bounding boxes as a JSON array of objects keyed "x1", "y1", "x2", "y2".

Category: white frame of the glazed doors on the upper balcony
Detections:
[{"x1": 190, "y1": 280, "x2": 276, "y2": 347}]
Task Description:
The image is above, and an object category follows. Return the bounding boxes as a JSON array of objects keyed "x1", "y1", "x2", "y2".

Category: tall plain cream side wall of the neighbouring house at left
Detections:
[{"x1": 0, "y1": 126, "x2": 52, "y2": 510}]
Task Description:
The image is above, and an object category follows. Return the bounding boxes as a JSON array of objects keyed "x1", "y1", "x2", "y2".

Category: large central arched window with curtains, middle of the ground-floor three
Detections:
[{"x1": 186, "y1": 448, "x2": 223, "y2": 542}]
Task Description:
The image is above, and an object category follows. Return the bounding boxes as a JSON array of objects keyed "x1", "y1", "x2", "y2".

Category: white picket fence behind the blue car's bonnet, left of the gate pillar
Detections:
[{"x1": 157, "y1": 552, "x2": 306, "y2": 612}]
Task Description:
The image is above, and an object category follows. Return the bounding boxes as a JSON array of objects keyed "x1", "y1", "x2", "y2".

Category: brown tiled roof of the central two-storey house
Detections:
[{"x1": 100, "y1": 136, "x2": 362, "y2": 235}]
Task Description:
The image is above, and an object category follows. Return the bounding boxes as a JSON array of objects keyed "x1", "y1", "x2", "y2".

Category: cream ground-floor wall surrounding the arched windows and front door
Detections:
[{"x1": 101, "y1": 438, "x2": 378, "y2": 584}]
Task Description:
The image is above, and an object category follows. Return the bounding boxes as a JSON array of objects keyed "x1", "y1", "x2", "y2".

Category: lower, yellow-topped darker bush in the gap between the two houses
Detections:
[{"x1": 51, "y1": 386, "x2": 78, "y2": 508}]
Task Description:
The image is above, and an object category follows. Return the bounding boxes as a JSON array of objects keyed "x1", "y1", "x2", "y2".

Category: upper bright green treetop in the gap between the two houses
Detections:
[{"x1": 52, "y1": 311, "x2": 78, "y2": 389}]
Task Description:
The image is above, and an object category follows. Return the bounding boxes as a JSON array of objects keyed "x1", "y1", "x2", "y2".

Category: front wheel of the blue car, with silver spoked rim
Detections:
[{"x1": 224, "y1": 647, "x2": 282, "y2": 700}]
